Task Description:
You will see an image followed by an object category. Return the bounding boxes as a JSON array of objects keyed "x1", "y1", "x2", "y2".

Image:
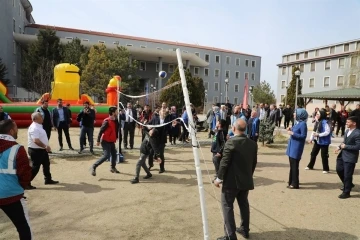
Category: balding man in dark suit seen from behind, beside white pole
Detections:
[{"x1": 214, "y1": 119, "x2": 258, "y2": 240}]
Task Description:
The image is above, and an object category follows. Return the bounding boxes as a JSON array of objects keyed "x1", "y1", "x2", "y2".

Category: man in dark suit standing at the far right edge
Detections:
[{"x1": 335, "y1": 117, "x2": 360, "y2": 199}]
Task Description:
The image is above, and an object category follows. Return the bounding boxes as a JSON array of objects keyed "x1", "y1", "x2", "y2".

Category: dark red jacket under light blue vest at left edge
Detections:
[{"x1": 0, "y1": 139, "x2": 31, "y2": 205}]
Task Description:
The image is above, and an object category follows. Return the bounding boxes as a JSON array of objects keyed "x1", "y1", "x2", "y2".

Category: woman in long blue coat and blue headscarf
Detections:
[{"x1": 286, "y1": 108, "x2": 308, "y2": 189}]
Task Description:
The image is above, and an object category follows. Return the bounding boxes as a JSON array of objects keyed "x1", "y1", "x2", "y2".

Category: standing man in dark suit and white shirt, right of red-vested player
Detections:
[{"x1": 123, "y1": 103, "x2": 137, "y2": 149}]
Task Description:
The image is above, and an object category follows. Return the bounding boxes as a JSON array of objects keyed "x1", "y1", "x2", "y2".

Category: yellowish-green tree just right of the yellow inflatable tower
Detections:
[{"x1": 81, "y1": 44, "x2": 112, "y2": 97}]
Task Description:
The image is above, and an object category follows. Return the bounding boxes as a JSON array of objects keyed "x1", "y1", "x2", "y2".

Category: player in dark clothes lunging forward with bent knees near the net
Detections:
[{"x1": 130, "y1": 128, "x2": 161, "y2": 184}]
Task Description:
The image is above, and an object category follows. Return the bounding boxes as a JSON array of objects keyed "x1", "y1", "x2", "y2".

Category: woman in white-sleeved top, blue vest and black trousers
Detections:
[{"x1": 305, "y1": 109, "x2": 331, "y2": 173}]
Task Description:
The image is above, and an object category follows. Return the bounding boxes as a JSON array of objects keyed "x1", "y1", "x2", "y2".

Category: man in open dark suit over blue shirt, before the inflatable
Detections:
[{"x1": 52, "y1": 98, "x2": 74, "y2": 151}]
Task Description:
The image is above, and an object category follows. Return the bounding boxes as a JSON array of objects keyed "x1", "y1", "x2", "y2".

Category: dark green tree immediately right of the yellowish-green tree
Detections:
[{"x1": 107, "y1": 47, "x2": 141, "y2": 95}]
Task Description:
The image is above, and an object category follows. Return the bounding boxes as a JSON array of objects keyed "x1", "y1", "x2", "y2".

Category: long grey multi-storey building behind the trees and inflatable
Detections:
[{"x1": 0, "y1": 0, "x2": 261, "y2": 104}]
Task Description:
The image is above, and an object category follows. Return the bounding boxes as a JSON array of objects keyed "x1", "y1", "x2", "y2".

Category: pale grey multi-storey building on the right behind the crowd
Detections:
[{"x1": 277, "y1": 39, "x2": 360, "y2": 109}]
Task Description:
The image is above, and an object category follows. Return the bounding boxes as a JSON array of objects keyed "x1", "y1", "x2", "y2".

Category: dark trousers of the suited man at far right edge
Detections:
[{"x1": 336, "y1": 156, "x2": 356, "y2": 193}]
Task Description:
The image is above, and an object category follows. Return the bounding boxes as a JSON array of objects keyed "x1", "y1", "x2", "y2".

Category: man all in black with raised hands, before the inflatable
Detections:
[{"x1": 76, "y1": 102, "x2": 95, "y2": 154}]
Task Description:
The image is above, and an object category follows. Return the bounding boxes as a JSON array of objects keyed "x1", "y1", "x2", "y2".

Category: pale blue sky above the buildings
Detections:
[{"x1": 30, "y1": 0, "x2": 360, "y2": 90}]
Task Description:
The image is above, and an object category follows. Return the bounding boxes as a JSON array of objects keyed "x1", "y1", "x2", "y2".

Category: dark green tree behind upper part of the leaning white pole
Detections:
[{"x1": 160, "y1": 68, "x2": 205, "y2": 107}]
